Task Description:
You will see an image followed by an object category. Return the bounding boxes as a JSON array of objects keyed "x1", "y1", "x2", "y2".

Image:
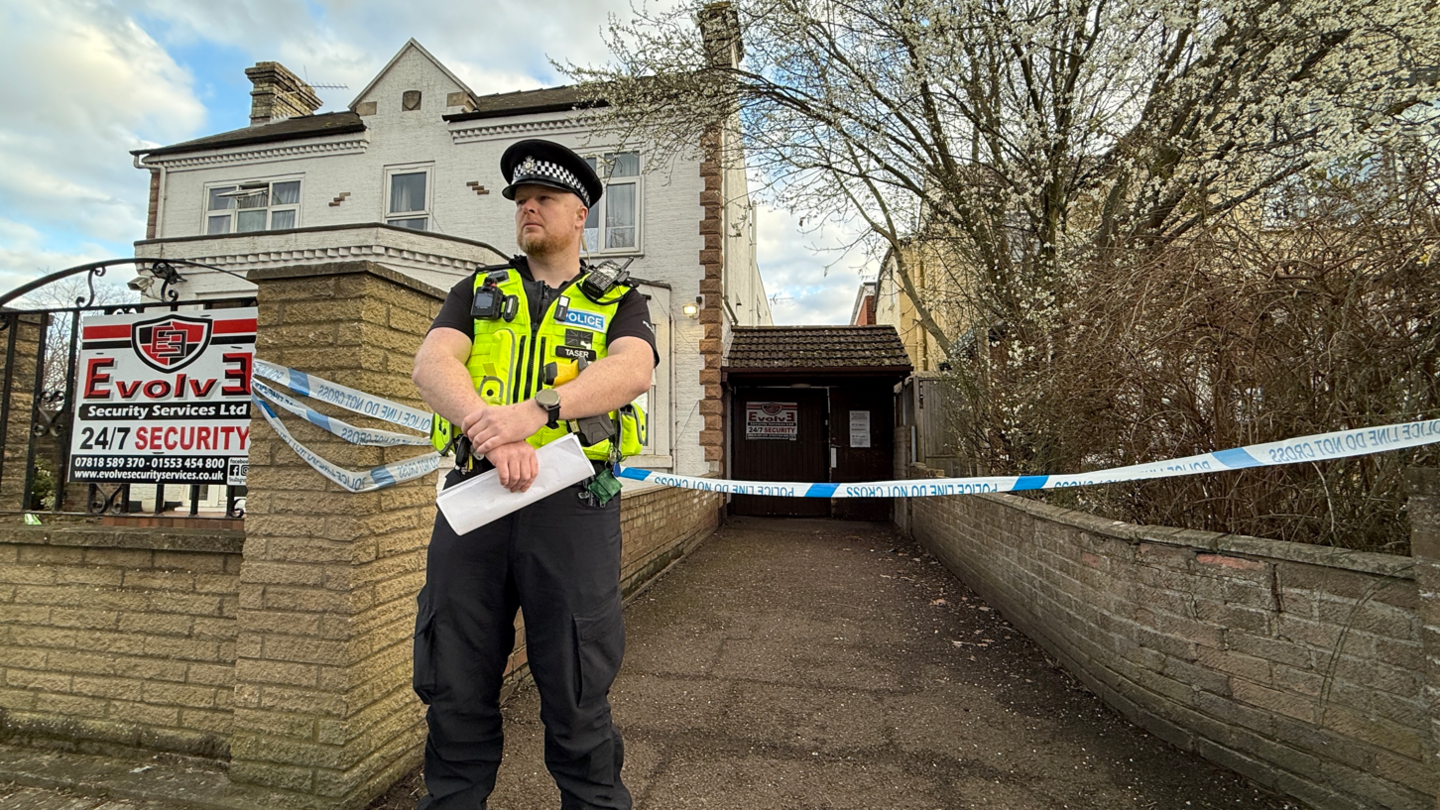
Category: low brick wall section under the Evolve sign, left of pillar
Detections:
[{"x1": 0, "y1": 526, "x2": 243, "y2": 757}]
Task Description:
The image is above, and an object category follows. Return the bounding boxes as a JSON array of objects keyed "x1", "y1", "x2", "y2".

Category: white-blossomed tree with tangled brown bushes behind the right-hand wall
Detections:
[{"x1": 567, "y1": 0, "x2": 1440, "y2": 548}]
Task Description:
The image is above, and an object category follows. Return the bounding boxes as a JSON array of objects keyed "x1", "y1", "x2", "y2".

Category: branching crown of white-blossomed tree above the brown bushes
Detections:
[{"x1": 566, "y1": 0, "x2": 1440, "y2": 352}]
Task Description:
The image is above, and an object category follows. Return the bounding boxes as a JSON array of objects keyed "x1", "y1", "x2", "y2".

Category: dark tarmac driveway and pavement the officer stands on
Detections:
[{"x1": 0, "y1": 519, "x2": 1296, "y2": 810}]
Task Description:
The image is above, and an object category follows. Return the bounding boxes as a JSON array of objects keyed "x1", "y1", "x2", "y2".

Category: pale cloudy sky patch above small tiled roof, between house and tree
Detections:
[{"x1": 756, "y1": 205, "x2": 878, "y2": 326}]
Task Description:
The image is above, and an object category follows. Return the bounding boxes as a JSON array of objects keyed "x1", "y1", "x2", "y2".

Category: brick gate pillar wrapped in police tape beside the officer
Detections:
[{"x1": 230, "y1": 262, "x2": 444, "y2": 807}]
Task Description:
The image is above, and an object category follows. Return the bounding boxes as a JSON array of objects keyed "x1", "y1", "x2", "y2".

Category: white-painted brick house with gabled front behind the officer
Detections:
[{"x1": 135, "y1": 25, "x2": 770, "y2": 474}]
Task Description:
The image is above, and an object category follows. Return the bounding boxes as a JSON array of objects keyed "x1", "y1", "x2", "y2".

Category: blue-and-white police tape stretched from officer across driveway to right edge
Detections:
[{"x1": 615, "y1": 419, "x2": 1440, "y2": 497}]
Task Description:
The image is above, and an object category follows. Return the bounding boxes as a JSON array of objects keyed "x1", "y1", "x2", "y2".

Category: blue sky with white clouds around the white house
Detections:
[{"x1": 0, "y1": 0, "x2": 868, "y2": 324}]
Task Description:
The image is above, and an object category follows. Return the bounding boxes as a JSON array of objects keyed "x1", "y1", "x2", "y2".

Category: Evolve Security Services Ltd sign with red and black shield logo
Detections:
[{"x1": 69, "y1": 307, "x2": 256, "y2": 486}]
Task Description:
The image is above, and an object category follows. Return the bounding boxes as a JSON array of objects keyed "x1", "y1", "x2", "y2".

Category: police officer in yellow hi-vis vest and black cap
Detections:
[{"x1": 413, "y1": 140, "x2": 660, "y2": 810}]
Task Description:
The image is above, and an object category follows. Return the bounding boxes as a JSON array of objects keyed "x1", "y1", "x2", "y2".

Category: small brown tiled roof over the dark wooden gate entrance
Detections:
[{"x1": 726, "y1": 324, "x2": 910, "y2": 375}]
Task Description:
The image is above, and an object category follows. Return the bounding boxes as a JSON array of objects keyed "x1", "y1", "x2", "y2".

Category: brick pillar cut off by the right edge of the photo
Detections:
[{"x1": 1408, "y1": 467, "x2": 1440, "y2": 810}]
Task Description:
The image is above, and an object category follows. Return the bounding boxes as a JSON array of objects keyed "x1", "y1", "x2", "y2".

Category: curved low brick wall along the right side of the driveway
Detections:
[{"x1": 909, "y1": 467, "x2": 1440, "y2": 810}]
